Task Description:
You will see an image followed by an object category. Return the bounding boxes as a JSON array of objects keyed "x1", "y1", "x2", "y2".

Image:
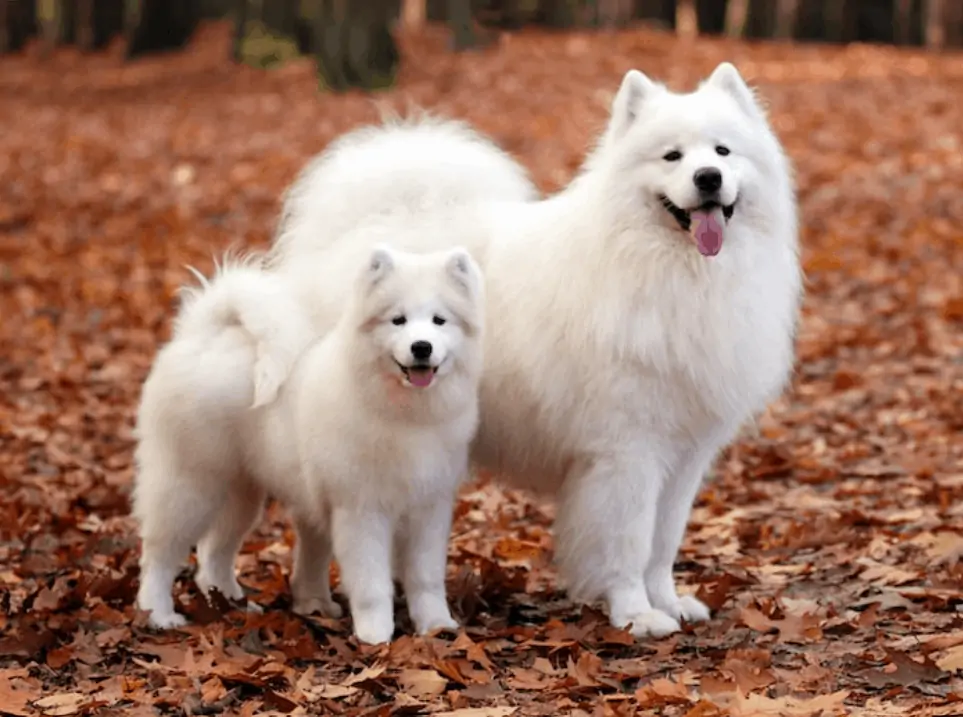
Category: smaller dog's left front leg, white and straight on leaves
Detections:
[{"x1": 331, "y1": 508, "x2": 395, "y2": 644}]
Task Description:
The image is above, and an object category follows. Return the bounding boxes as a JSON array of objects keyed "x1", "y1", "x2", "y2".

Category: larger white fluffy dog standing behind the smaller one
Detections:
[{"x1": 270, "y1": 63, "x2": 802, "y2": 636}]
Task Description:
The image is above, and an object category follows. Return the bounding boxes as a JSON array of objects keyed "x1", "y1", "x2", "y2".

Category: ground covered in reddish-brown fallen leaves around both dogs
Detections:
[{"x1": 0, "y1": 19, "x2": 963, "y2": 717}]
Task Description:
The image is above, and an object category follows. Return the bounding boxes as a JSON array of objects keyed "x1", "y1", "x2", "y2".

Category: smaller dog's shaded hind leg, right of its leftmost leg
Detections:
[{"x1": 194, "y1": 482, "x2": 265, "y2": 607}]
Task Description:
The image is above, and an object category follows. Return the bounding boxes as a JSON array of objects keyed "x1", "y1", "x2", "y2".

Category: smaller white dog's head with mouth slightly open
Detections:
[{"x1": 356, "y1": 244, "x2": 484, "y2": 389}]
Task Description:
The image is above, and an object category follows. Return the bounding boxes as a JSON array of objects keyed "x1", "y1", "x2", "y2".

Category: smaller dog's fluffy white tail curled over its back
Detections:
[{"x1": 174, "y1": 256, "x2": 313, "y2": 408}]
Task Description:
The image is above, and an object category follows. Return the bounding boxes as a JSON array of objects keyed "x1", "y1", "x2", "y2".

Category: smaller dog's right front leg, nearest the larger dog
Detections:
[{"x1": 401, "y1": 490, "x2": 458, "y2": 634}]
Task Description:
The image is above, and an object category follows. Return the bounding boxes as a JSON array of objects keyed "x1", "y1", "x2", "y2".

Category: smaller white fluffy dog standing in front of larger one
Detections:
[{"x1": 133, "y1": 246, "x2": 484, "y2": 643}]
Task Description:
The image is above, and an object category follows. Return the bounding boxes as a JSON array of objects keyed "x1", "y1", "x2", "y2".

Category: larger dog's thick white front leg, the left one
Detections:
[{"x1": 555, "y1": 451, "x2": 680, "y2": 637}]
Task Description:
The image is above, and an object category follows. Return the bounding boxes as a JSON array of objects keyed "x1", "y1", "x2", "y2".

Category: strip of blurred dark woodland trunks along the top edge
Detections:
[{"x1": 0, "y1": 0, "x2": 963, "y2": 57}]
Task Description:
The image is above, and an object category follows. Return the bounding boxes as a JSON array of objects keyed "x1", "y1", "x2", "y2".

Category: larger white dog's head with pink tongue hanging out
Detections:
[{"x1": 601, "y1": 63, "x2": 787, "y2": 256}]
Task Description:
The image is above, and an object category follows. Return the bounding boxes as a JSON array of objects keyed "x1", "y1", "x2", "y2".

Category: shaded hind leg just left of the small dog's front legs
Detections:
[{"x1": 291, "y1": 515, "x2": 342, "y2": 618}]
